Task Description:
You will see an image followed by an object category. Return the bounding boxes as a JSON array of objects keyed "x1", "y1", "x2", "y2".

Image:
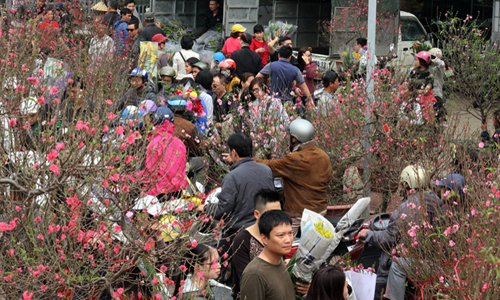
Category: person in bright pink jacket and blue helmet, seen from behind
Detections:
[{"x1": 138, "y1": 107, "x2": 187, "y2": 201}]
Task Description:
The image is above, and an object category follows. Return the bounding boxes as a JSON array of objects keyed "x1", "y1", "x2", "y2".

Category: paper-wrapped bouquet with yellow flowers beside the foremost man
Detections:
[{"x1": 288, "y1": 198, "x2": 370, "y2": 299}]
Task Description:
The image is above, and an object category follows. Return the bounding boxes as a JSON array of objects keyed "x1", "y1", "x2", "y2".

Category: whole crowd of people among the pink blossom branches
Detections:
[{"x1": 1, "y1": 0, "x2": 500, "y2": 300}]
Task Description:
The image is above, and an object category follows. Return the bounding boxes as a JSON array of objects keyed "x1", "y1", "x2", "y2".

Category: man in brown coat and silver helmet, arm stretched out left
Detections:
[{"x1": 255, "y1": 119, "x2": 332, "y2": 234}]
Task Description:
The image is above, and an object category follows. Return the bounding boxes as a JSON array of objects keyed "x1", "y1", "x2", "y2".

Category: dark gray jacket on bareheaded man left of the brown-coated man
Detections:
[{"x1": 205, "y1": 158, "x2": 274, "y2": 231}]
